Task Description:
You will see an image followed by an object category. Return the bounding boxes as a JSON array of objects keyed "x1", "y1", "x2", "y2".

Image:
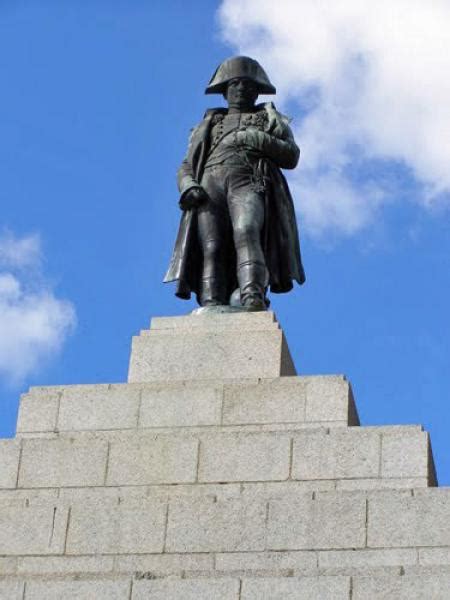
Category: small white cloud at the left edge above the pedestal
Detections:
[{"x1": 0, "y1": 232, "x2": 75, "y2": 383}]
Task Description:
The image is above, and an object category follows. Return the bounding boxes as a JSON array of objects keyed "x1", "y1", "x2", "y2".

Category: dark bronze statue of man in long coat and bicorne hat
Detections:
[{"x1": 164, "y1": 56, "x2": 305, "y2": 311}]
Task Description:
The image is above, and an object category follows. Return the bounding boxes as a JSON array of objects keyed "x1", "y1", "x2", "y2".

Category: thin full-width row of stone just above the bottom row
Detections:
[{"x1": 0, "y1": 548, "x2": 450, "y2": 579}]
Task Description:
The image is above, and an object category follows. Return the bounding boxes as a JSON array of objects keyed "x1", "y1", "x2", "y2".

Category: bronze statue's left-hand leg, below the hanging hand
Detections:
[{"x1": 198, "y1": 169, "x2": 228, "y2": 306}]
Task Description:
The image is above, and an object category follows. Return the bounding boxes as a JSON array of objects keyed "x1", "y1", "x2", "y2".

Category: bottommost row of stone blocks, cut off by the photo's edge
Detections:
[{"x1": 0, "y1": 573, "x2": 450, "y2": 600}]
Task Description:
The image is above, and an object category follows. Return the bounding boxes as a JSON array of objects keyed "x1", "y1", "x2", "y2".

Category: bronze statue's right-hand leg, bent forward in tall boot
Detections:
[{"x1": 228, "y1": 171, "x2": 267, "y2": 309}]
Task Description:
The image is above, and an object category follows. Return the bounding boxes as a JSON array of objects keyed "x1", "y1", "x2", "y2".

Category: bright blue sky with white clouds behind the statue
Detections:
[{"x1": 0, "y1": 0, "x2": 450, "y2": 484}]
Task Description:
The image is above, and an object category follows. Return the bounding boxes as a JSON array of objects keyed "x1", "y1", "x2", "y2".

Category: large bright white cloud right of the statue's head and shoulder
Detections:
[{"x1": 219, "y1": 0, "x2": 450, "y2": 234}]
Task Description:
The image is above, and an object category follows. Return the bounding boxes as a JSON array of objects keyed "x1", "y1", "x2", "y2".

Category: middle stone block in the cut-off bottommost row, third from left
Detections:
[{"x1": 132, "y1": 578, "x2": 239, "y2": 600}]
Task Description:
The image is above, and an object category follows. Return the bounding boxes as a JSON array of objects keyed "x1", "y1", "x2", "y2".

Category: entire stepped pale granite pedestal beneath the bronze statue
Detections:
[{"x1": 0, "y1": 313, "x2": 444, "y2": 600}]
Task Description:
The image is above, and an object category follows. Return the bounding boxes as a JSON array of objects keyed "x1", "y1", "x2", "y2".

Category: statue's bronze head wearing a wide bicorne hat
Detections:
[{"x1": 205, "y1": 56, "x2": 276, "y2": 106}]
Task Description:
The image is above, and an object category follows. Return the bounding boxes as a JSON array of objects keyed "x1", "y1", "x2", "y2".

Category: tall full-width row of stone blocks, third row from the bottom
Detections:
[{"x1": 0, "y1": 488, "x2": 450, "y2": 557}]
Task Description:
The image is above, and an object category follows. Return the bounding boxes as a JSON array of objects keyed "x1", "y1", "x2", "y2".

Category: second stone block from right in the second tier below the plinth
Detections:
[{"x1": 292, "y1": 429, "x2": 380, "y2": 479}]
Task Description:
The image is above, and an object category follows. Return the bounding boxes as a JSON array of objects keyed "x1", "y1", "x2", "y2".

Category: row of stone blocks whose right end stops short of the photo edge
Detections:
[{"x1": 0, "y1": 426, "x2": 435, "y2": 489}]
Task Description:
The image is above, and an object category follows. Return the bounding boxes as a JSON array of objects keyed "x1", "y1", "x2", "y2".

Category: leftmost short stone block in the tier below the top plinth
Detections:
[{"x1": 17, "y1": 387, "x2": 61, "y2": 432}]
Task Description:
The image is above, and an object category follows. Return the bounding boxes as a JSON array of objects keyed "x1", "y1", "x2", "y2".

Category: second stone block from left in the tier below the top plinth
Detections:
[{"x1": 58, "y1": 384, "x2": 140, "y2": 431}]
